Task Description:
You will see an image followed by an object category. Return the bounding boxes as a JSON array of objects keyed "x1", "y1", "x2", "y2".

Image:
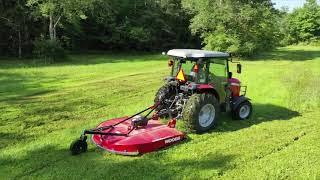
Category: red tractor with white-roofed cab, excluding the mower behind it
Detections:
[{"x1": 154, "y1": 49, "x2": 252, "y2": 133}]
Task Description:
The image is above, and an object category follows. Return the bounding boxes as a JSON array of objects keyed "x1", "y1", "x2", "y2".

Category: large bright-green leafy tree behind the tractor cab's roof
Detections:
[{"x1": 183, "y1": 0, "x2": 279, "y2": 55}]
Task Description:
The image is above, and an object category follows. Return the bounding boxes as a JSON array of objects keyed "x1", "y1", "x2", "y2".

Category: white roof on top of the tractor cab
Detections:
[{"x1": 167, "y1": 49, "x2": 230, "y2": 58}]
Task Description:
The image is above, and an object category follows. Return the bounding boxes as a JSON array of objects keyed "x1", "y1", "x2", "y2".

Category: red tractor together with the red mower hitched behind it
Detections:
[{"x1": 70, "y1": 49, "x2": 252, "y2": 155}]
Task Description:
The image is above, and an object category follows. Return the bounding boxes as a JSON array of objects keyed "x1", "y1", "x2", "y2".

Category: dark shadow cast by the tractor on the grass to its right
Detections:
[{"x1": 212, "y1": 104, "x2": 300, "y2": 132}]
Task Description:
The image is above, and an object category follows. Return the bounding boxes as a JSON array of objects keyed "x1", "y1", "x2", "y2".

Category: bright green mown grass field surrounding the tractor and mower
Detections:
[{"x1": 0, "y1": 46, "x2": 320, "y2": 179}]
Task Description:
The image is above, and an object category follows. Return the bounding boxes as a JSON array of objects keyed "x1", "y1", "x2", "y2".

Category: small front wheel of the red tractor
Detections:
[{"x1": 231, "y1": 100, "x2": 252, "y2": 120}]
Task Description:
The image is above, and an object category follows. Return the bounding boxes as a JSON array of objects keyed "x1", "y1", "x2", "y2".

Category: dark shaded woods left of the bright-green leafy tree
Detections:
[{"x1": 0, "y1": 0, "x2": 198, "y2": 56}]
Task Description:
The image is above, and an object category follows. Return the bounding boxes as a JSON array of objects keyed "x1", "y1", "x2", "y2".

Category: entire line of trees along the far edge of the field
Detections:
[{"x1": 0, "y1": 0, "x2": 320, "y2": 59}]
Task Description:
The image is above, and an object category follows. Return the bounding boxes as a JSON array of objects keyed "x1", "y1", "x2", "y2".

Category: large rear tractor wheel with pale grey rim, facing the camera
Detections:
[{"x1": 182, "y1": 94, "x2": 220, "y2": 133}]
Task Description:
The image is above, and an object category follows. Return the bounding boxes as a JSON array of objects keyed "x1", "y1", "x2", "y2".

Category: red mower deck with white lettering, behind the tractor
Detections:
[{"x1": 92, "y1": 117, "x2": 185, "y2": 155}]
